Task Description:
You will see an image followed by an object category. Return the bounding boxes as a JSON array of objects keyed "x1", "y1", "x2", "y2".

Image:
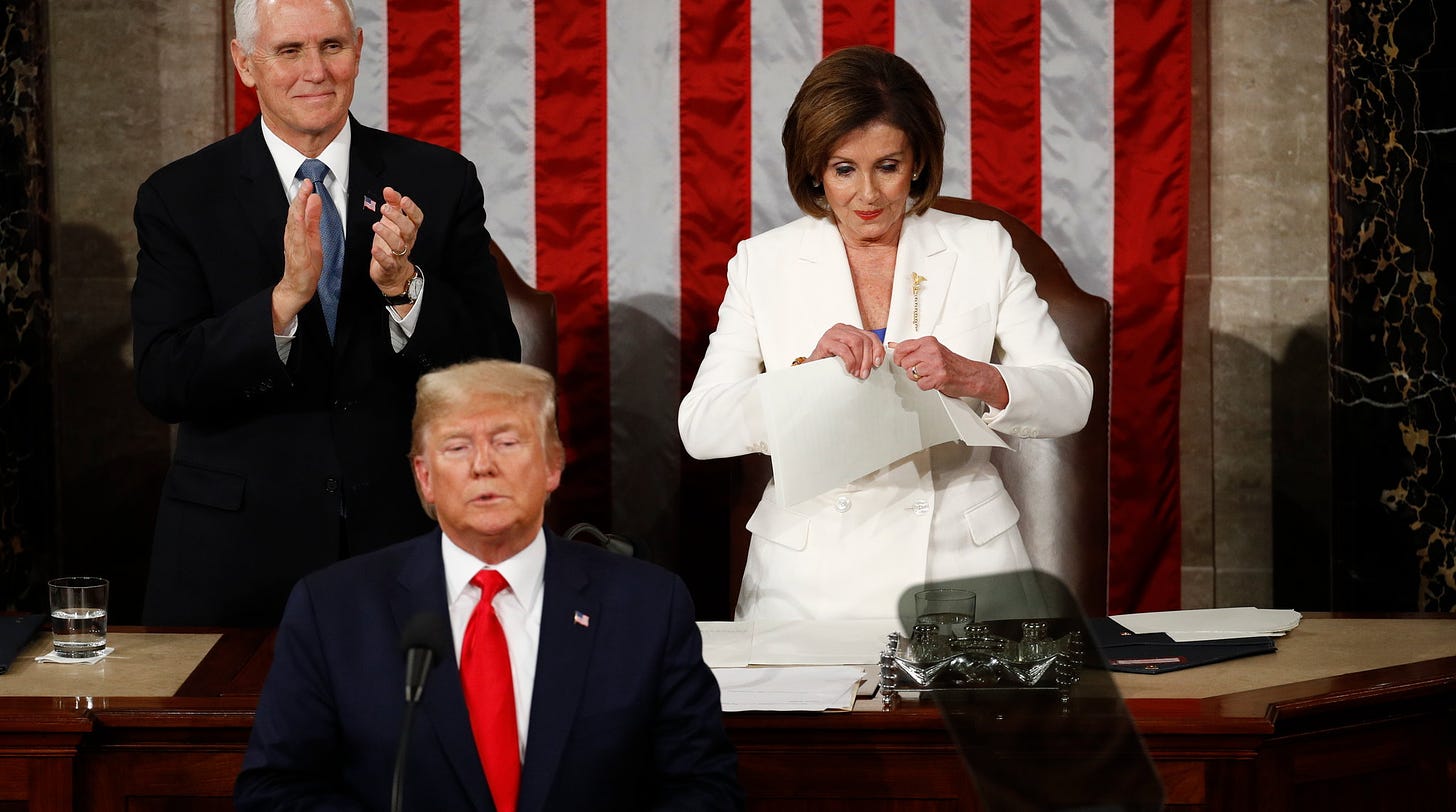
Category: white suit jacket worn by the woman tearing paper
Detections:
[{"x1": 678, "y1": 210, "x2": 1092, "y2": 618}]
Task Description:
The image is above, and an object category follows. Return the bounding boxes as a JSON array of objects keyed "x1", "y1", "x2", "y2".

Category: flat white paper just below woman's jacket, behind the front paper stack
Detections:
[{"x1": 753, "y1": 617, "x2": 900, "y2": 665}]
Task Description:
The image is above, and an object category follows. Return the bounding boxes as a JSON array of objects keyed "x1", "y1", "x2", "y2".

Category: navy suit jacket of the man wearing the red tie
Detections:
[{"x1": 237, "y1": 530, "x2": 743, "y2": 812}]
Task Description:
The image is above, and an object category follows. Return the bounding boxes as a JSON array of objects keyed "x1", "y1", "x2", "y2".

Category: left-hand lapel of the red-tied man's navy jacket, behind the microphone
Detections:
[{"x1": 390, "y1": 530, "x2": 491, "y2": 811}]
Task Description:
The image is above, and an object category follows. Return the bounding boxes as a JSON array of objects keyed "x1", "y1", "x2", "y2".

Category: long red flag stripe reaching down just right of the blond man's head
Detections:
[{"x1": 535, "y1": 0, "x2": 613, "y2": 527}]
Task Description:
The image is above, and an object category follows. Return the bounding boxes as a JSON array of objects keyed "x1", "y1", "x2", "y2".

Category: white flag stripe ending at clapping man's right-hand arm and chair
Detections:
[{"x1": 460, "y1": 0, "x2": 536, "y2": 285}]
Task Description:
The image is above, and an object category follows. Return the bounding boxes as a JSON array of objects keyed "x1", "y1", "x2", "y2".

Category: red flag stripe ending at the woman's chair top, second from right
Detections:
[{"x1": 971, "y1": 0, "x2": 1041, "y2": 231}]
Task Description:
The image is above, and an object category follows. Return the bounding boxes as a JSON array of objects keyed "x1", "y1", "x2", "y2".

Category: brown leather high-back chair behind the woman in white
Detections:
[{"x1": 729, "y1": 196, "x2": 1111, "y2": 616}]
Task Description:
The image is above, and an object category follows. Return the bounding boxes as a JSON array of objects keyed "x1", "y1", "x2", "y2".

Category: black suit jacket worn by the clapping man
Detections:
[{"x1": 131, "y1": 119, "x2": 520, "y2": 626}]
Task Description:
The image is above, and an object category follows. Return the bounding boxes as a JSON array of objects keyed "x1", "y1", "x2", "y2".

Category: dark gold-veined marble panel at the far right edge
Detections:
[{"x1": 1329, "y1": 0, "x2": 1456, "y2": 611}]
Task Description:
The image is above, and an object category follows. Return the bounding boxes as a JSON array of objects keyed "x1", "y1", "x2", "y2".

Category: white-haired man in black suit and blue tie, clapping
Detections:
[{"x1": 132, "y1": 0, "x2": 520, "y2": 626}]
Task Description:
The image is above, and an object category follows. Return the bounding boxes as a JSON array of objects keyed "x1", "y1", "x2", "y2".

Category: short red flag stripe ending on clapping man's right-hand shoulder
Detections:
[{"x1": 387, "y1": 0, "x2": 460, "y2": 151}]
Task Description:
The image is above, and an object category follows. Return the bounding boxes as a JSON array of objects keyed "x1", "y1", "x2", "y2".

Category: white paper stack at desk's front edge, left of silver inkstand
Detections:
[{"x1": 713, "y1": 665, "x2": 865, "y2": 712}]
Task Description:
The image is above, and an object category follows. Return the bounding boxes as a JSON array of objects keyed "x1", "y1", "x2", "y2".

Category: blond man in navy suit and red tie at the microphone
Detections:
[{"x1": 236, "y1": 361, "x2": 743, "y2": 812}]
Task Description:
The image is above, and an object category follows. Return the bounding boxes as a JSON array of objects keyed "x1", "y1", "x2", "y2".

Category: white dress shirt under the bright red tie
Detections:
[{"x1": 440, "y1": 530, "x2": 546, "y2": 763}]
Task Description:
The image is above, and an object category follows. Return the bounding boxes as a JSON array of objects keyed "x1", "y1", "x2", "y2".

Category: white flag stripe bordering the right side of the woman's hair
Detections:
[{"x1": 895, "y1": 0, "x2": 971, "y2": 198}]
